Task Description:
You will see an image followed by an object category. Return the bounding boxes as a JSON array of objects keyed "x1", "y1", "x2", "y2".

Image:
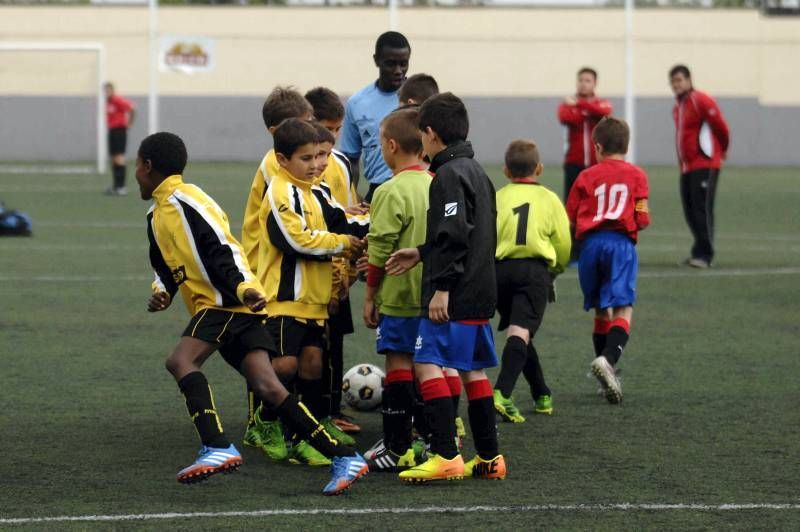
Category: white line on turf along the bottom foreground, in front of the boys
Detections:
[{"x1": 0, "y1": 503, "x2": 800, "y2": 525}]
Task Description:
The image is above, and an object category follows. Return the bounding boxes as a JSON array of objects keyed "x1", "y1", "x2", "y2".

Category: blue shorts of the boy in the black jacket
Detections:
[{"x1": 414, "y1": 318, "x2": 497, "y2": 371}]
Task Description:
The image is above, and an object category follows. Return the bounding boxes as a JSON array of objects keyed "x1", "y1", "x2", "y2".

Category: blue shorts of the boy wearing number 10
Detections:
[{"x1": 578, "y1": 231, "x2": 639, "y2": 310}]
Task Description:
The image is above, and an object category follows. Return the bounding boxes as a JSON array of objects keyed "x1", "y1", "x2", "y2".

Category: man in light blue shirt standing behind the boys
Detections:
[{"x1": 339, "y1": 31, "x2": 411, "y2": 203}]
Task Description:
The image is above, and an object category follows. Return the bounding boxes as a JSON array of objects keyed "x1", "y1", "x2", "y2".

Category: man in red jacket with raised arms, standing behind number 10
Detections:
[{"x1": 558, "y1": 67, "x2": 612, "y2": 202}]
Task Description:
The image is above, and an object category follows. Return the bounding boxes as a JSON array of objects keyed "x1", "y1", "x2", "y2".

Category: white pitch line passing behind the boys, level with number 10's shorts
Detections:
[{"x1": 0, "y1": 266, "x2": 800, "y2": 283}]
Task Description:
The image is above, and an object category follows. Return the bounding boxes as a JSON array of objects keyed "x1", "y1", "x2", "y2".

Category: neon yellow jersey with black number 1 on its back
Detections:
[{"x1": 495, "y1": 182, "x2": 572, "y2": 273}]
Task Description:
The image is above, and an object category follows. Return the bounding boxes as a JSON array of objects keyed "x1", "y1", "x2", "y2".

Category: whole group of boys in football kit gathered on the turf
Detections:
[{"x1": 136, "y1": 32, "x2": 648, "y2": 495}]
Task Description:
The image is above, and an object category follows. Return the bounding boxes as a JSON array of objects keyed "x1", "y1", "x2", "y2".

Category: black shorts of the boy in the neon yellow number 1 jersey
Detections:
[{"x1": 495, "y1": 259, "x2": 551, "y2": 338}]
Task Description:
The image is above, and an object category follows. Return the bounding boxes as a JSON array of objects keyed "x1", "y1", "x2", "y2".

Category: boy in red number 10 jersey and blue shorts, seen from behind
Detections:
[{"x1": 567, "y1": 118, "x2": 650, "y2": 404}]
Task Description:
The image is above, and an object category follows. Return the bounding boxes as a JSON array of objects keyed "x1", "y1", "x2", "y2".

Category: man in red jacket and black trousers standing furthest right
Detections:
[{"x1": 669, "y1": 65, "x2": 730, "y2": 268}]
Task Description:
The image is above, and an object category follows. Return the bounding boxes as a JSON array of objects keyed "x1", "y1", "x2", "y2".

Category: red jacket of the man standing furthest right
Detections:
[{"x1": 672, "y1": 89, "x2": 730, "y2": 174}]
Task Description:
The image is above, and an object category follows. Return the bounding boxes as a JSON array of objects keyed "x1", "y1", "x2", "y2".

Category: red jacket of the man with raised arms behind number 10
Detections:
[{"x1": 558, "y1": 96, "x2": 612, "y2": 168}]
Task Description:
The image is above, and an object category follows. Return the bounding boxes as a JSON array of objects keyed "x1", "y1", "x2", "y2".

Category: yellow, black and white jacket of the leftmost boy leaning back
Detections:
[{"x1": 147, "y1": 175, "x2": 263, "y2": 315}]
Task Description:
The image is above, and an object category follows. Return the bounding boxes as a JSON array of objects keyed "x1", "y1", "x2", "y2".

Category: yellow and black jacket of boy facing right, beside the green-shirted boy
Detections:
[{"x1": 257, "y1": 168, "x2": 350, "y2": 320}]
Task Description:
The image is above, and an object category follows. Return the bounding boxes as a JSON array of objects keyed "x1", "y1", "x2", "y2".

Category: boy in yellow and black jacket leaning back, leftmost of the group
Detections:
[{"x1": 136, "y1": 133, "x2": 367, "y2": 495}]
